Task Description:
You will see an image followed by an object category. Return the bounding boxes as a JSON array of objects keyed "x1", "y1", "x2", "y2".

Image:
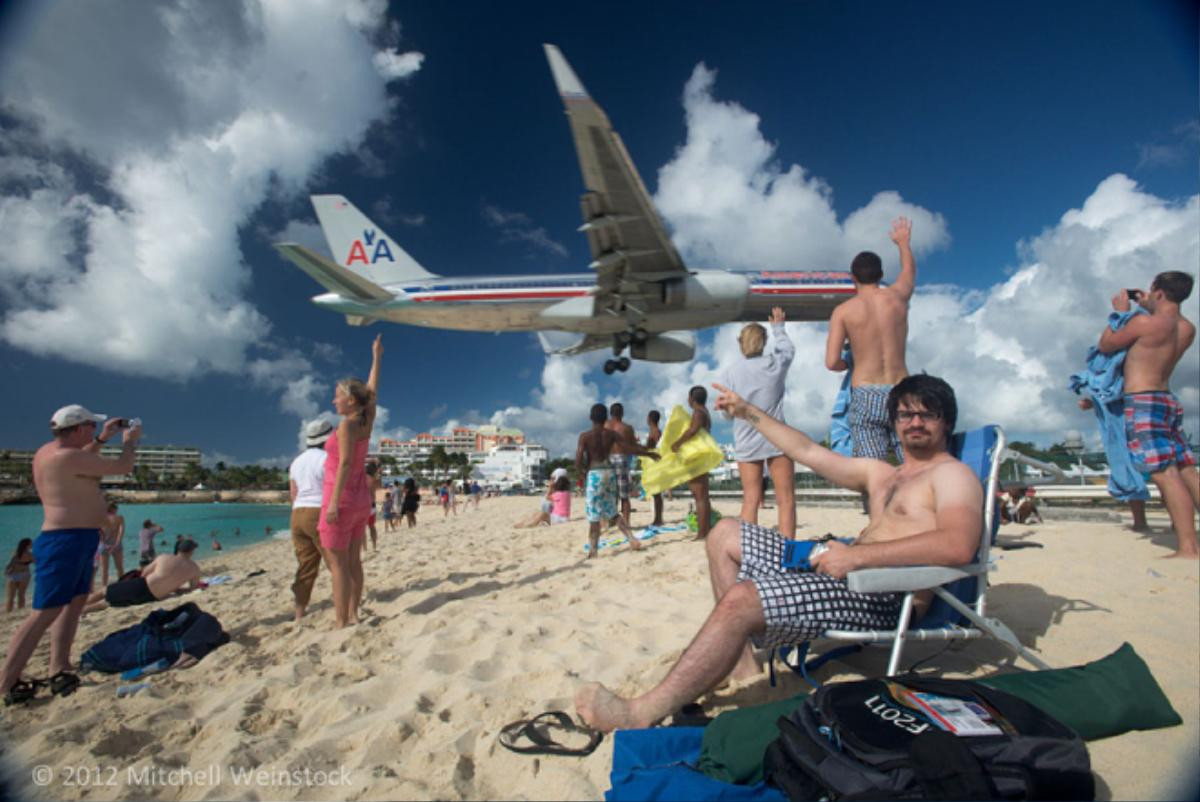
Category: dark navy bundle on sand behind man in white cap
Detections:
[{"x1": 79, "y1": 602, "x2": 229, "y2": 674}]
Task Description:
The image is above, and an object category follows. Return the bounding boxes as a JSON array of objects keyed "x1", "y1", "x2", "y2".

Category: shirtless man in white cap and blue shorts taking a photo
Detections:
[{"x1": 0, "y1": 403, "x2": 142, "y2": 705}]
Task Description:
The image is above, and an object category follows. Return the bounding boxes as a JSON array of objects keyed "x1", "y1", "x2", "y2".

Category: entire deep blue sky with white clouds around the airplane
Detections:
[{"x1": 0, "y1": 0, "x2": 1200, "y2": 462}]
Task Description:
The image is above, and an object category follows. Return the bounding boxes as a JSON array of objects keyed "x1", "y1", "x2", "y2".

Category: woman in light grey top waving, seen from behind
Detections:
[{"x1": 725, "y1": 306, "x2": 796, "y2": 539}]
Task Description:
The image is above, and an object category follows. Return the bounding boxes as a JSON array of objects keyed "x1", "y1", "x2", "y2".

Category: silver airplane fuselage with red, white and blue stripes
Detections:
[{"x1": 312, "y1": 270, "x2": 854, "y2": 335}]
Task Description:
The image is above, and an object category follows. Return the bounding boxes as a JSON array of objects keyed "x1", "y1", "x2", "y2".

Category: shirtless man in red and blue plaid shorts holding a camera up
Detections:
[{"x1": 1099, "y1": 270, "x2": 1200, "y2": 559}]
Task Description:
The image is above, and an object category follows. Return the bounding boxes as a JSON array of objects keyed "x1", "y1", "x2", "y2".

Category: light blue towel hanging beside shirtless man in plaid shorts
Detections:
[{"x1": 1068, "y1": 304, "x2": 1150, "y2": 502}]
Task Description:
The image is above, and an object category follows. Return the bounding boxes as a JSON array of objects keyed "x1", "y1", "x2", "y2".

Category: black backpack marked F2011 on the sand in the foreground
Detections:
[{"x1": 763, "y1": 676, "x2": 1096, "y2": 802}]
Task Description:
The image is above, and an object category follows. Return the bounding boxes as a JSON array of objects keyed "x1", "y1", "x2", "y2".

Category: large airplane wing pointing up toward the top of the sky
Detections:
[{"x1": 544, "y1": 44, "x2": 688, "y2": 295}]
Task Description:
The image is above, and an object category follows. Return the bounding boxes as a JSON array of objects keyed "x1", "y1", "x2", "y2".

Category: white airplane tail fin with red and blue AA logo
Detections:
[{"x1": 310, "y1": 194, "x2": 437, "y2": 285}]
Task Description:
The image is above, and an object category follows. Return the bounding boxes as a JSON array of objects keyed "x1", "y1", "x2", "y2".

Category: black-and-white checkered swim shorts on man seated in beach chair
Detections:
[{"x1": 738, "y1": 521, "x2": 901, "y2": 648}]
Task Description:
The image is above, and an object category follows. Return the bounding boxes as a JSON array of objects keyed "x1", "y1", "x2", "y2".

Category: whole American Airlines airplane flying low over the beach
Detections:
[{"x1": 275, "y1": 44, "x2": 854, "y2": 375}]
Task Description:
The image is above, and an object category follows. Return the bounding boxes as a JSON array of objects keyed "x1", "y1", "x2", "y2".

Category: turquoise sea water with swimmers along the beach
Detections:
[{"x1": 0, "y1": 503, "x2": 292, "y2": 570}]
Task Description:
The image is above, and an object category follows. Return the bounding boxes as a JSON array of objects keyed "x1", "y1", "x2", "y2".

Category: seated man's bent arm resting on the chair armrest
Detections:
[{"x1": 812, "y1": 461, "x2": 983, "y2": 579}]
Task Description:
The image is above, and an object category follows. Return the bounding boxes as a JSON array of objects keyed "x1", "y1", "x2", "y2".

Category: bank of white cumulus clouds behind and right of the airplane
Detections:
[{"x1": 460, "y1": 65, "x2": 1200, "y2": 454}]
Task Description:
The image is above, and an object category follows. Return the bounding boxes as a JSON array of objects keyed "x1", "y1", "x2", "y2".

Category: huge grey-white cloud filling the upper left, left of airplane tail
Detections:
[{"x1": 0, "y1": 0, "x2": 421, "y2": 393}]
